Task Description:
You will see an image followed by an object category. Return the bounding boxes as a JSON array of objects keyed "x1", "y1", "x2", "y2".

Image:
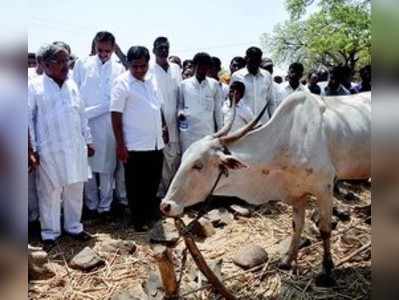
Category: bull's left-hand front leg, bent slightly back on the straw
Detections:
[{"x1": 279, "y1": 201, "x2": 306, "y2": 270}]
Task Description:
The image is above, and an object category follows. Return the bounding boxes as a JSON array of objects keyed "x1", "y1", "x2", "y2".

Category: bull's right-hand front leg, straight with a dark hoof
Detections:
[{"x1": 317, "y1": 191, "x2": 335, "y2": 286}]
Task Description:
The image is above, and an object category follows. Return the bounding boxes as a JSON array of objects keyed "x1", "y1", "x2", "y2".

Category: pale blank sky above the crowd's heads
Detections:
[{"x1": 27, "y1": 0, "x2": 288, "y2": 73}]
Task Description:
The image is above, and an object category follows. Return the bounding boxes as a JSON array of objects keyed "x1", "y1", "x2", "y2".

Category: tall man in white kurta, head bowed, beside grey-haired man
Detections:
[{"x1": 73, "y1": 32, "x2": 124, "y2": 214}]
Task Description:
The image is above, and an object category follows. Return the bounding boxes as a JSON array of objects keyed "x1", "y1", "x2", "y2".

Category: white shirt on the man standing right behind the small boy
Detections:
[{"x1": 230, "y1": 68, "x2": 273, "y2": 123}]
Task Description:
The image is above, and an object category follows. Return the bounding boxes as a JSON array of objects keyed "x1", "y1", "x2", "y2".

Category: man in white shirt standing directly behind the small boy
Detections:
[{"x1": 231, "y1": 47, "x2": 273, "y2": 124}]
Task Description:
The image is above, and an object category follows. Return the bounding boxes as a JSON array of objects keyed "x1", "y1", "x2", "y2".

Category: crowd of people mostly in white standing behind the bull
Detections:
[{"x1": 28, "y1": 31, "x2": 371, "y2": 250}]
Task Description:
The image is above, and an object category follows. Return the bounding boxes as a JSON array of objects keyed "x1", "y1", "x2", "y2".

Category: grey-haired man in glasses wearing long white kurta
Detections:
[{"x1": 28, "y1": 45, "x2": 93, "y2": 245}]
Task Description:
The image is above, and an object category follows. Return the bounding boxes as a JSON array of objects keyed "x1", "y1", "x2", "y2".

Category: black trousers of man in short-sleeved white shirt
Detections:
[{"x1": 125, "y1": 150, "x2": 163, "y2": 226}]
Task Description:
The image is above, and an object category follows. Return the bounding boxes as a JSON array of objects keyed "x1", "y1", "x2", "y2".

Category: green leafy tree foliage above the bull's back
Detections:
[{"x1": 262, "y1": 0, "x2": 371, "y2": 69}]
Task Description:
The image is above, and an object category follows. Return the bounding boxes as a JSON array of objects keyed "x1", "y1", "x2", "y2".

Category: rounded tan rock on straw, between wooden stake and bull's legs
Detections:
[{"x1": 233, "y1": 245, "x2": 269, "y2": 269}]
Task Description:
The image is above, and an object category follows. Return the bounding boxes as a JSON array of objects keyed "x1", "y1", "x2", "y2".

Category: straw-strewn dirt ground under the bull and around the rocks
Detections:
[{"x1": 29, "y1": 182, "x2": 371, "y2": 299}]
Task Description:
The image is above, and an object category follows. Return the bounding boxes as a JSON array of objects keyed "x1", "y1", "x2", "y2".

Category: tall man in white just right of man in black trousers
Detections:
[{"x1": 149, "y1": 37, "x2": 182, "y2": 198}]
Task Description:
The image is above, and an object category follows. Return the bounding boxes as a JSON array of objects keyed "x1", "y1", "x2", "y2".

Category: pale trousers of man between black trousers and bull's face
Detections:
[{"x1": 158, "y1": 142, "x2": 181, "y2": 198}]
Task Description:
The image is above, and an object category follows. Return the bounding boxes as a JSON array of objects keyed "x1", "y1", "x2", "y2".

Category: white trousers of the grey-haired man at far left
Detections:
[{"x1": 37, "y1": 169, "x2": 83, "y2": 240}]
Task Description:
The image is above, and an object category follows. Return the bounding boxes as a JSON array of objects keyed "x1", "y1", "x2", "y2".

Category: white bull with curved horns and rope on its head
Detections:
[{"x1": 161, "y1": 92, "x2": 371, "y2": 279}]
